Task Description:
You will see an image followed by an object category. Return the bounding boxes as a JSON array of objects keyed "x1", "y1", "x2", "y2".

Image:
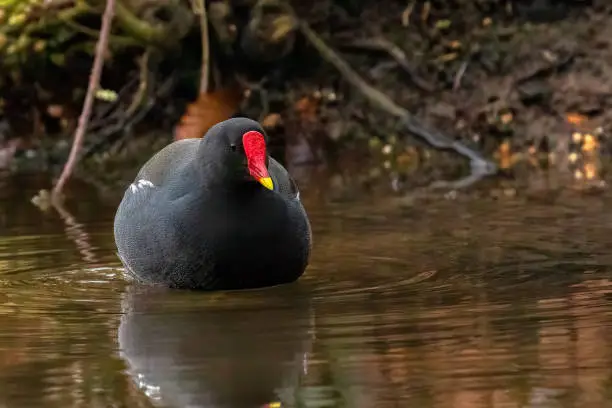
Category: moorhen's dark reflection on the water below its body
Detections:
[{"x1": 118, "y1": 285, "x2": 314, "y2": 407}]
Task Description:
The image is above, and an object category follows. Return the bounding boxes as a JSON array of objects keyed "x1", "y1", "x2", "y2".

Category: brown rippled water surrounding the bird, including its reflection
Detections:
[{"x1": 0, "y1": 173, "x2": 612, "y2": 408}]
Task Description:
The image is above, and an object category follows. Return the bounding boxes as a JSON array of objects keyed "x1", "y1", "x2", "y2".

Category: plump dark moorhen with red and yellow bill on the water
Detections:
[{"x1": 114, "y1": 118, "x2": 311, "y2": 290}]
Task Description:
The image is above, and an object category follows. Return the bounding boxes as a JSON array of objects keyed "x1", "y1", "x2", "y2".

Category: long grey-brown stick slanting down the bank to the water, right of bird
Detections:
[{"x1": 300, "y1": 21, "x2": 497, "y2": 188}]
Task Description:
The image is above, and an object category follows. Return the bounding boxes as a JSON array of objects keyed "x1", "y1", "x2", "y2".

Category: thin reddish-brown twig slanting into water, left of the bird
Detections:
[{"x1": 52, "y1": 0, "x2": 115, "y2": 201}]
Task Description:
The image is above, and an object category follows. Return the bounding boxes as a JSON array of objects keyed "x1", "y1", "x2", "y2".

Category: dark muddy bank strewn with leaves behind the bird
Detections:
[{"x1": 0, "y1": 0, "x2": 612, "y2": 194}]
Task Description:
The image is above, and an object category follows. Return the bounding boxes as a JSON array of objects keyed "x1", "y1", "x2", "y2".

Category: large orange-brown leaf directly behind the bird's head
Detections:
[{"x1": 174, "y1": 84, "x2": 243, "y2": 140}]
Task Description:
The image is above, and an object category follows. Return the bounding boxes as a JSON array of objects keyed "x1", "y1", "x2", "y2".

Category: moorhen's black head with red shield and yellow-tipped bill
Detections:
[{"x1": 200, "y1": 118, "x2": 274, "y2": 190}]
